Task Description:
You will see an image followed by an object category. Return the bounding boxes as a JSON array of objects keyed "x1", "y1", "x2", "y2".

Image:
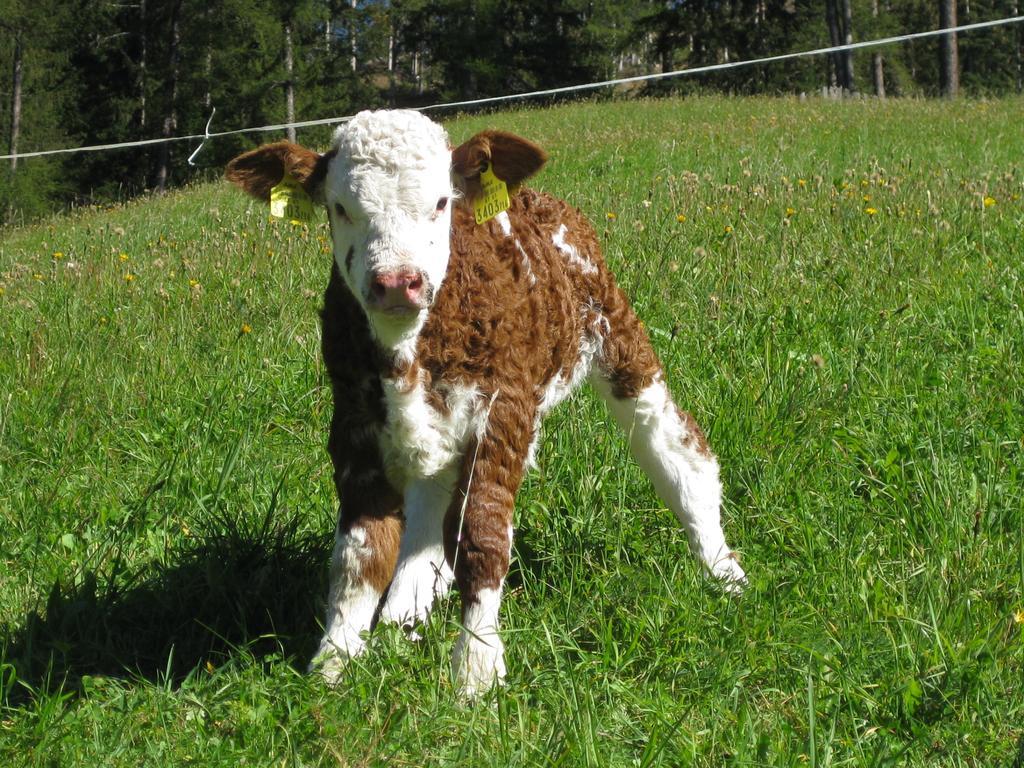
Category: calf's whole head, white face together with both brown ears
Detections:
[{"x1": 225, "y1": 110, "x2": 547, "y2": 359}]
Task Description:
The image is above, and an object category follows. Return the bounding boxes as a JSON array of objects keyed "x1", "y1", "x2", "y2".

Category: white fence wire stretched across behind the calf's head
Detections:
[{"x1": 0, "y1": 16, "x2": 1024, "y2": 160}]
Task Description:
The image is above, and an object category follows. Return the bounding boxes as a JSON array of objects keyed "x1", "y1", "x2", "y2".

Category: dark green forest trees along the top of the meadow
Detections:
[{"x1": 0, "y1": 0, "x2": 1024, "y2": 221}]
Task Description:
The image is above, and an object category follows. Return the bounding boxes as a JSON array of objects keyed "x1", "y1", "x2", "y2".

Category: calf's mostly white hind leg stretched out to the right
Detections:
[{"x1": 591, "y1": 311, "x2": 746, "y2": 592}]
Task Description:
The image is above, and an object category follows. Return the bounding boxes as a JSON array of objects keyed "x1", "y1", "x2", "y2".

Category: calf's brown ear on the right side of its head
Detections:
[{"x1": 452, "y1": 131, "x2": 548, "y2": 202}]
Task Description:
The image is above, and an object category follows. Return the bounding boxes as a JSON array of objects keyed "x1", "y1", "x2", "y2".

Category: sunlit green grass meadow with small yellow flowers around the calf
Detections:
[{"x1": 0, "y1": 98, "x2": 1024, "y2": 768}]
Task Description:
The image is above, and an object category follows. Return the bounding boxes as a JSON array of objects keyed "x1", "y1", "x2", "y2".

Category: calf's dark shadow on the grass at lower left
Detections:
[{"x1": 0, "y1": 520, "x2": 331, "y2": 706}]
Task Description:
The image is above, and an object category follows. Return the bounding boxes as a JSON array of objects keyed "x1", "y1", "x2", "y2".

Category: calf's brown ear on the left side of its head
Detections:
[{"x1": 224, "y1": 141, "x2": 334, "y2": 203}]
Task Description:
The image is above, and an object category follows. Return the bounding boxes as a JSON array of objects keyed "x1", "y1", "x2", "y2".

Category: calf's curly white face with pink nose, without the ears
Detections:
[{"x1": 323, "y1": 111, "x2": 454, "y2": 347}]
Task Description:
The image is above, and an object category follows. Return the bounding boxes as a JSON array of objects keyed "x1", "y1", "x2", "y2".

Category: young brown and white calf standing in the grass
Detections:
[{"x1": 226, "y1": 111, "x2": 744, "y2": 696}]
